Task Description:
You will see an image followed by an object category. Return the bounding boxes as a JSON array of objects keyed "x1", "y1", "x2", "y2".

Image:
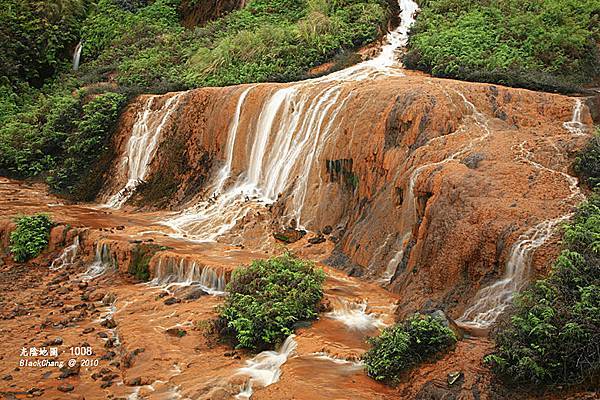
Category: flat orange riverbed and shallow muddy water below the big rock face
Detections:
[{"x1": 0, "y1": 179, "x2": 496, "y2": 399}]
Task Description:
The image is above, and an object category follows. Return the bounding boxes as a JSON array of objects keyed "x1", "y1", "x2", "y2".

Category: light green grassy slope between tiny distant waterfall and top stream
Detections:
[{"x1": 76, "y1": 0, "x2": 388, "y2": 91}]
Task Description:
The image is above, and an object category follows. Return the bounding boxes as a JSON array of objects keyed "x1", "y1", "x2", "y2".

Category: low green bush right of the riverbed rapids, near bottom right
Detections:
[{"x1": 364, "y1": 314, "x2": 456, "y2": 384}]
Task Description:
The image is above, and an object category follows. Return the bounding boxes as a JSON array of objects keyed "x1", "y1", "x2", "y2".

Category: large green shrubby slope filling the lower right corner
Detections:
[{"x1": 486, "y1": 195, "x2": 600, "y2": 386}]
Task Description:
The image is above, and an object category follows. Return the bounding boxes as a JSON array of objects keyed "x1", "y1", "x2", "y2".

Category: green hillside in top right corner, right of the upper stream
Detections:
[{"x1": 405, "y1": 0, "x2": 600, "y2": 91}]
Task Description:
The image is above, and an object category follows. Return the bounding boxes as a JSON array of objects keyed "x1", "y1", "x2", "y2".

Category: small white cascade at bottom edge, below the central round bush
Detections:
[{"x1": 235, "y1": 335, "x2": 297, "y2": 400}]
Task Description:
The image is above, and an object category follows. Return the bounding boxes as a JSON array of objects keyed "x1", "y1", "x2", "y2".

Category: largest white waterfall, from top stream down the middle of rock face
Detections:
[{"x1": 163, "y1": 0, "x2": 418, "y2": 241}]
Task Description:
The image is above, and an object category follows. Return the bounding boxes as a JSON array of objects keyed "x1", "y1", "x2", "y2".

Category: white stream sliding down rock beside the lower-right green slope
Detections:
[{"x1": 457, "y1": 215, "x2": 570, "y2": 328}]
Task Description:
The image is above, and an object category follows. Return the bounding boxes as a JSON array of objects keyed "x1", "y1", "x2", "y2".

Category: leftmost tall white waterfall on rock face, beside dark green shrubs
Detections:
[{"x1": 106, "y1": 92, "x2": 183, "y2": 208}]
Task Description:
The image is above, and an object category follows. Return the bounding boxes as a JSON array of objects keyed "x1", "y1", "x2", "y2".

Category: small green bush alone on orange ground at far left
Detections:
[{"x1": 10, "y1": 214, "x2": 53, "y2": 262}]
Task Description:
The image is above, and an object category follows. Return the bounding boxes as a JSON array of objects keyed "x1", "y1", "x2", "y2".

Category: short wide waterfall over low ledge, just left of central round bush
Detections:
[{"x1": 151, "y1": 256, "x2": 227, "y2": 295}]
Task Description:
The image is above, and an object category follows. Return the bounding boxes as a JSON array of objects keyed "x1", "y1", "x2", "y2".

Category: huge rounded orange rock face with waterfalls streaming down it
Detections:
[{"x1": 105, "y1": 76, "x2": 591, "y2": 317}]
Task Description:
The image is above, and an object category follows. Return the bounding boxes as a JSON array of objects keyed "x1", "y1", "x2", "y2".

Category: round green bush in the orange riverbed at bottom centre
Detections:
[{"x1": 217, "y1": 254, "x2": 325, "y2": 350}]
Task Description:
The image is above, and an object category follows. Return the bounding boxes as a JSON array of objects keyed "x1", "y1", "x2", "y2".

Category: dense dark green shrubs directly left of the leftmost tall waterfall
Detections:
[{"x1": 0, "y1": 87, "x2": 126, "y2": 198}]
